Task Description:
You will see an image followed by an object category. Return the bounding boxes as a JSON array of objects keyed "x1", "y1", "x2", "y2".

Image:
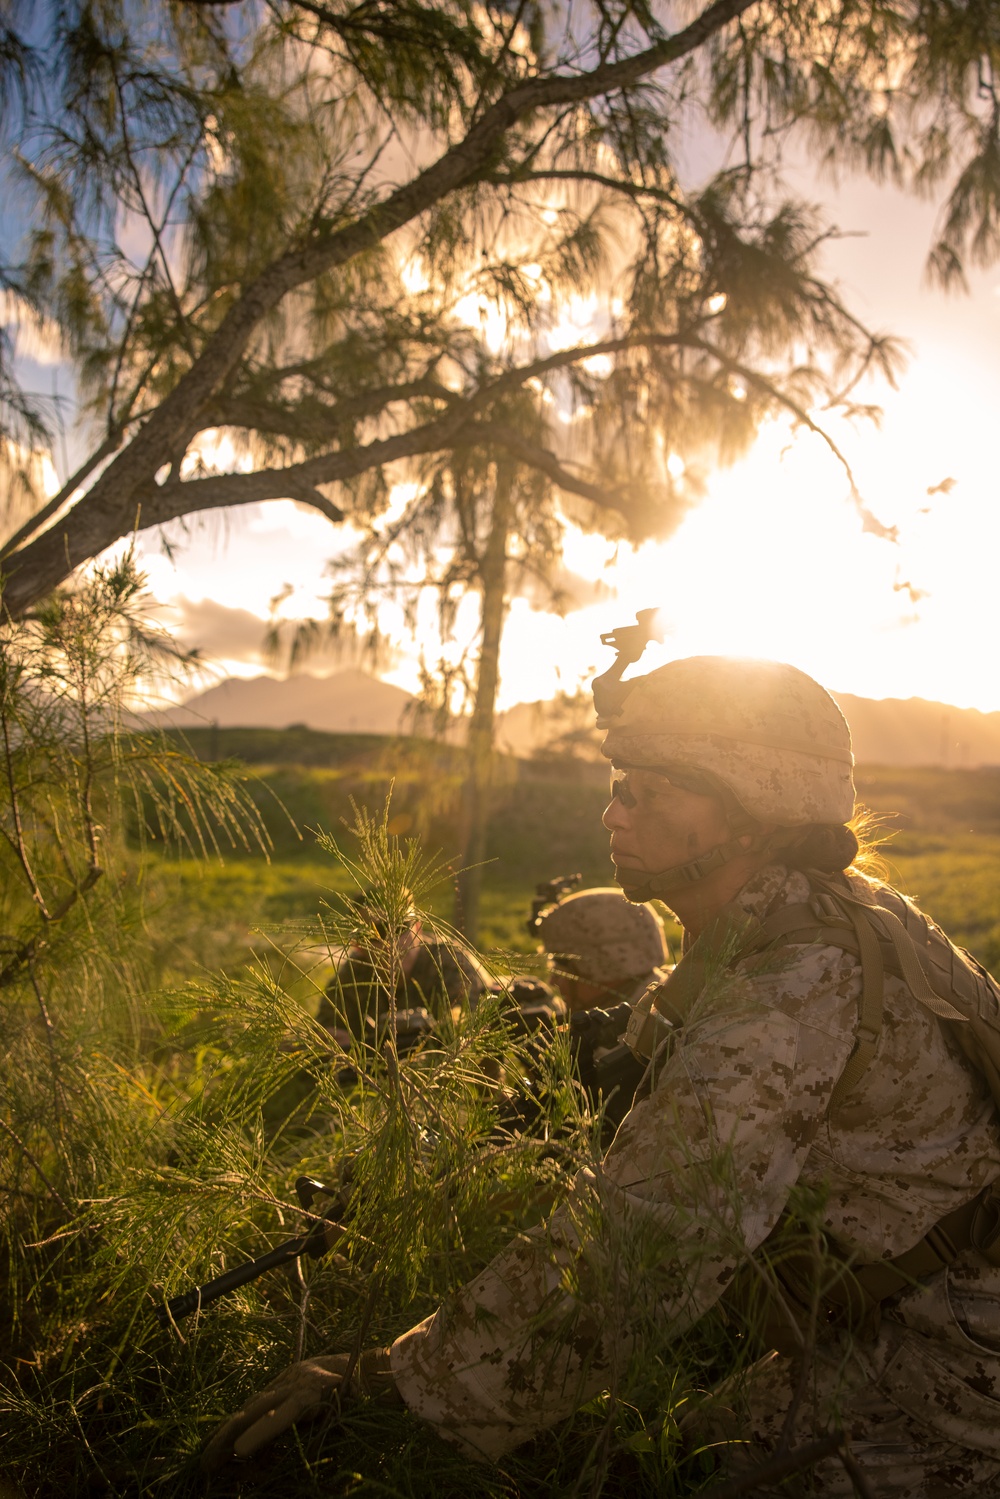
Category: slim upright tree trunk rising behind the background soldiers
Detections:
[{"x1": 456, "y1": 460, "x2": 514, "y2": 943}]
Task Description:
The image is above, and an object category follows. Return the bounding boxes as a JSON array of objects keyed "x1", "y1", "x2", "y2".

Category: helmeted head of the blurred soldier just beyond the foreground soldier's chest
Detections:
[{"x1": 529, "y1": 887, "x2": 670, "y2": 1015}]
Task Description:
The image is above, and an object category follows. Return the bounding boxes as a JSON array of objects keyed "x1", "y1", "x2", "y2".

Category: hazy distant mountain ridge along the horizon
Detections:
[{"x1": 145, "y1": 669, "x2": 1000, "y2": 770}]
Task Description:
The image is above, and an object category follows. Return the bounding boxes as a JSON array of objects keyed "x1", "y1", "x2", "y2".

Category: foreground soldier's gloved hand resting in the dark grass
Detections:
[{"x1": 201, "y1": 1348, "x2": 402, "y2": 1474}]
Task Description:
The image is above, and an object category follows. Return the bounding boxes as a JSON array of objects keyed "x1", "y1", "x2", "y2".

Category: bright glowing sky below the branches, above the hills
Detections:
[{"x1": 7, "y1": 130, "x2": 1000, "y2": 711}]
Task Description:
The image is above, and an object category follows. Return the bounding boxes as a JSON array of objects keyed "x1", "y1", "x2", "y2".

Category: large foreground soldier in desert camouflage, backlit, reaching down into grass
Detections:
[{"x1": 208, "y1": 657, "x2": 1000, "y2": 1499}]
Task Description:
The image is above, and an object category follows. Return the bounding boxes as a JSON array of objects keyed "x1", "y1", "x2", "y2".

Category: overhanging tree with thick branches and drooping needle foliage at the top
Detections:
[{"x1": 0, "y1": 0, "x2": 1000, "y2": 615}]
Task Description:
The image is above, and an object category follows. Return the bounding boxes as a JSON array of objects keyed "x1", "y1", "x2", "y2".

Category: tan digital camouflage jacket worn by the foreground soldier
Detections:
[{"x1": 391, "y1": 865, "x2": 1000, "y2": 1457}]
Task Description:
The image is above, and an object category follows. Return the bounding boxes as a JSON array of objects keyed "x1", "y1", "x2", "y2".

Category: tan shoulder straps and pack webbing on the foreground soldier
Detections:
[{"x1": 625, "y1": 869, "x2": 1000, "y2": 1328}]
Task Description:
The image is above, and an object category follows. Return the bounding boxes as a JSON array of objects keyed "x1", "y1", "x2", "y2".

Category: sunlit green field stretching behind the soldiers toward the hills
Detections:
[{"x1": 144, "y1": 729, "x2": 1000, "y2": 976}]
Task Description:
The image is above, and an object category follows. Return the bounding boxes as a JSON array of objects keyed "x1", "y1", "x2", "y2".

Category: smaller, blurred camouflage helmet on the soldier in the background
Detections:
[{"x1": 535, "y1": 887, "x2": 669, "y2": 988}]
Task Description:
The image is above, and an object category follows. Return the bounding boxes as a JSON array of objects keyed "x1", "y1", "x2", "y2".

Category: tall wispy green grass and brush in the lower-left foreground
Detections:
[{"x1": 0, "y1": 821, "x2": 680, "y2": 1496}]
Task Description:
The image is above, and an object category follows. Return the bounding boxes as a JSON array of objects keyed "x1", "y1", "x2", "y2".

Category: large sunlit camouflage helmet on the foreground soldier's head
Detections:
[{"x1": 598, "y1": 657, "x2": 855, "y2": 827}]
